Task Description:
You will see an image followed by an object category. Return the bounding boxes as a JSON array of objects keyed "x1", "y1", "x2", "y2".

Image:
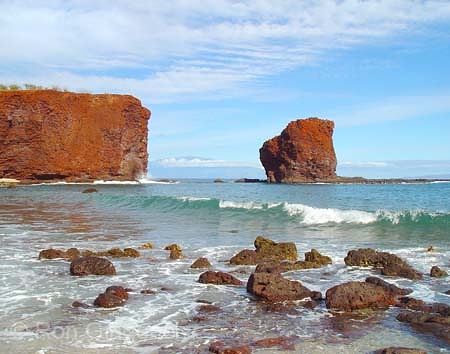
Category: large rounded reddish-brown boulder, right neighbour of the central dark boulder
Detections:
[{"x1": 325, "y1": 281, "x2": 395, "y2": 311}]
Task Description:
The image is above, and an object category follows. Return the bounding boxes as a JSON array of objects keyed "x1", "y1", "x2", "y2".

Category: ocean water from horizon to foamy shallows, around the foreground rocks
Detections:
[{"x1": 0, "y1": 180, "x2": 450, "y2": 354}]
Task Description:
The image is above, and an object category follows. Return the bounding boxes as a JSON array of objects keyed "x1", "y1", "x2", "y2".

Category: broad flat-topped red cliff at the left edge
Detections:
[{"x1": 0, "y1": 90, "x2": 150, "y2": 181}]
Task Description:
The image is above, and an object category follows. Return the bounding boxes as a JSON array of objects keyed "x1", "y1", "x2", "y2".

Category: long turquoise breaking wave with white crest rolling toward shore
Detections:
[{"x1": 99, "y1": 195, "x2": 450, "y2": 225}]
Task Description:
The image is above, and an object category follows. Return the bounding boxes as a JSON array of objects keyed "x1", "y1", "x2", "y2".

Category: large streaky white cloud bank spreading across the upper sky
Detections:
[{"x1": 0, "y1": 0, "x2": 450, "y2": 102}]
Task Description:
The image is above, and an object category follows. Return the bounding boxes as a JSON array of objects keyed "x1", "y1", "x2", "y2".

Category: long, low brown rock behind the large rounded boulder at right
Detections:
[{"x1": 344, "y1": 248, "x2": 422, "y2": 280}]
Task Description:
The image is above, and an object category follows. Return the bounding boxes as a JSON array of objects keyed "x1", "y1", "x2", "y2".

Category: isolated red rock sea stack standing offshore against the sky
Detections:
[{"x1": 259, "y1": 118, "x2": 336, "y2": 183}]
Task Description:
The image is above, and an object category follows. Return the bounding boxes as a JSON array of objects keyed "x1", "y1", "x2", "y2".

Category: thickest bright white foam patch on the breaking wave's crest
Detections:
[{"x1": 283, "y1": 203, "x2": 377, "y2": 225}]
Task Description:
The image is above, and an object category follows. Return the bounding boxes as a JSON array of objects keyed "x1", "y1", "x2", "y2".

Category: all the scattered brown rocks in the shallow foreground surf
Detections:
[{"x1": 39, "y1": 236, "x2": 450, "y2": 354}]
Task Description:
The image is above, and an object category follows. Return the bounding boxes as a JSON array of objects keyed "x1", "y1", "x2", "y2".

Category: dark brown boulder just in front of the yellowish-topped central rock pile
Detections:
[{"x1": 247, "y1": 273, "x2": 314, "y2": 302}]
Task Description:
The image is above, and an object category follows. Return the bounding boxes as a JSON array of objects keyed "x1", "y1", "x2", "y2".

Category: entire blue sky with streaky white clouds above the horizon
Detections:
[{"x1": 0, "y1": 0, "x2": 450, "y2": 177}]
